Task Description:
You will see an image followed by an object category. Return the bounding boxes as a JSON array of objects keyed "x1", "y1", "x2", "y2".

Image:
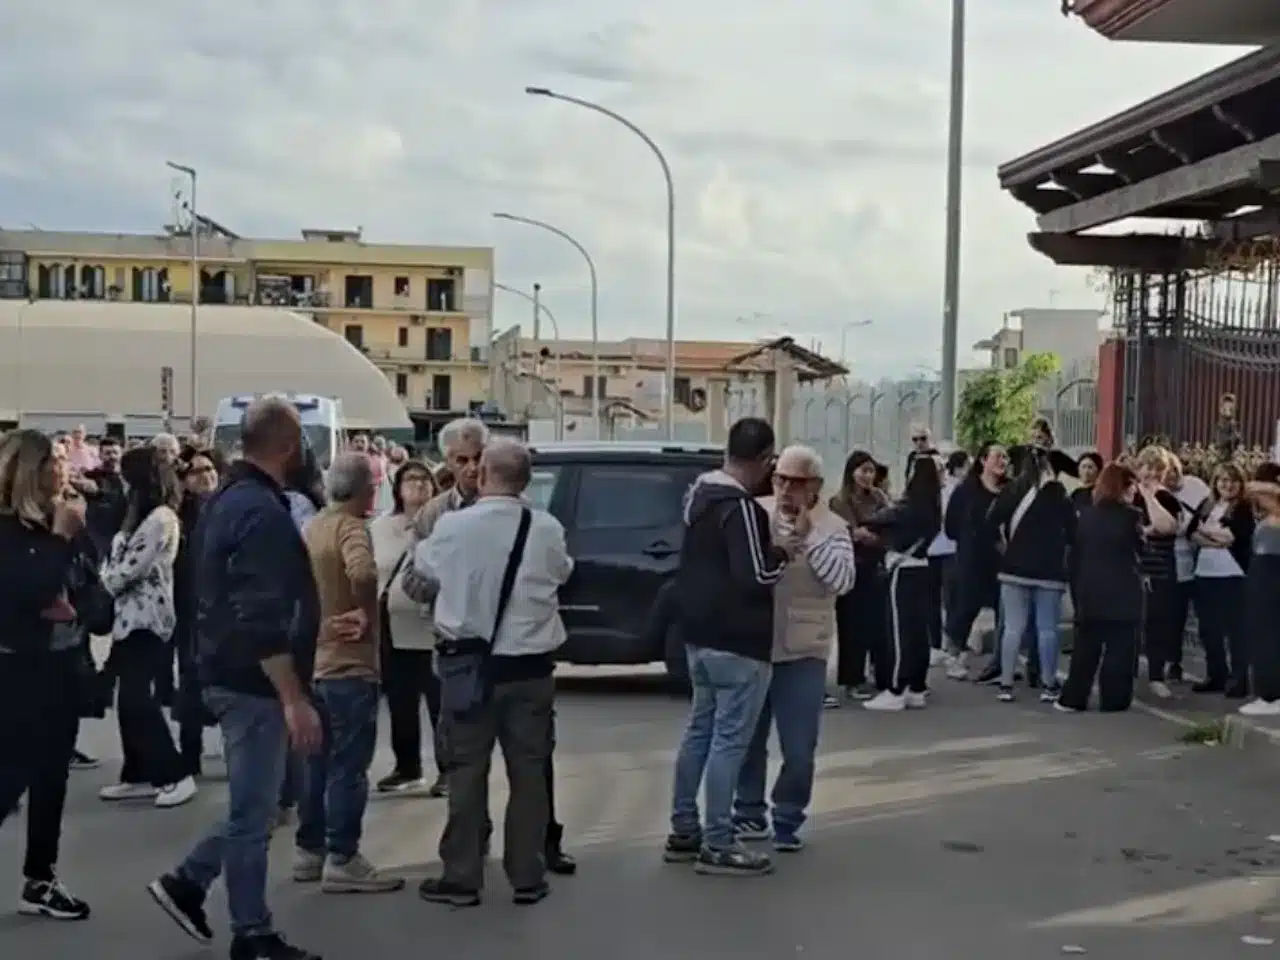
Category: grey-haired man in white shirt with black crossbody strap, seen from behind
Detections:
[{"x1": 413, "y1": 439, "x2": 573, "y2": 906}]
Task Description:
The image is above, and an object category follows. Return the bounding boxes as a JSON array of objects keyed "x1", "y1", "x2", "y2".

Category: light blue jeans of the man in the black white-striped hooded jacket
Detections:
[{"x1": 671, "y1": 644, "x2": 773, "y2": 850}]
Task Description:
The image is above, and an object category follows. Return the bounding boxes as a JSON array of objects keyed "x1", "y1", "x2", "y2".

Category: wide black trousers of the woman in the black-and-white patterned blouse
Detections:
[{"x1": 111, "y1": 630, "x2": 188, "y2": 787}]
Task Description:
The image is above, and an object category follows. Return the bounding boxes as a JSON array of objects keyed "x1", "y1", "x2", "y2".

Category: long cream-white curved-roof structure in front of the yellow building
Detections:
[{"x1": 0, "y1": 300, "x2": 412, "y2": 433}]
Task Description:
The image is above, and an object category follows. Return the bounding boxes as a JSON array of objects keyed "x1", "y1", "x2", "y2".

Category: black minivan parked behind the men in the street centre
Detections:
[{"x1": 527, "y1": 443, "x2": 724, "y2": 680}]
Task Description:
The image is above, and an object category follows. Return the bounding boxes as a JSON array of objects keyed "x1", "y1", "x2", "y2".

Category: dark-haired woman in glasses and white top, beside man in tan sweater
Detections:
[{"x1": 369, "y1": 461, "x2": 445, "y2": 796}]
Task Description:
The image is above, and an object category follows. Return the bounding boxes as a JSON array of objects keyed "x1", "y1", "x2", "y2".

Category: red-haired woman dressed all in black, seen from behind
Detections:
[{"x1": 1055, "y1": 463, "x2": 1146, "y2": 713}]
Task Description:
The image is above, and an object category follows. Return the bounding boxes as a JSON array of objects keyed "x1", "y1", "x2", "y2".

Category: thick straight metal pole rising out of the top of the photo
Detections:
[{"x1": 942, "y1": 0, "x2": 965, "y2": 440}]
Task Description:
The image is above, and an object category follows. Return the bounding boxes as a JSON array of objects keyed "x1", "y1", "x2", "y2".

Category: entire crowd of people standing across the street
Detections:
[{"x1": 0, "y1": 409, "x2": 1280, "y2": 960}]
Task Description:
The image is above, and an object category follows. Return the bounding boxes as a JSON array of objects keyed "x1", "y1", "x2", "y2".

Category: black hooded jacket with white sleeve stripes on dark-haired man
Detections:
[{"x1": 675, "y1": 470, "x2": 786, "y2": 663}]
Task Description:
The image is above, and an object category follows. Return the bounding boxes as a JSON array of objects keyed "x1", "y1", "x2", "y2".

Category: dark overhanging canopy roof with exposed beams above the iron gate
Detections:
[{"x1": 997, "y1": 47, "x2": 1280, "y2": 233}]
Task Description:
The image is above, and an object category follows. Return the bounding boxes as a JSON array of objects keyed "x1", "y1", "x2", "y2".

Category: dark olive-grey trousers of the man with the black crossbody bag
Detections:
[{"x1": 440, "y1": 677, "x2": 556, "y2": 890}]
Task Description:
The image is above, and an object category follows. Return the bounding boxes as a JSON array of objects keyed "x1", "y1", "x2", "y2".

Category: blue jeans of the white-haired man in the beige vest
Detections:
[{"x1": 733, "y1": 658, "x2": 827, "y2": 840}]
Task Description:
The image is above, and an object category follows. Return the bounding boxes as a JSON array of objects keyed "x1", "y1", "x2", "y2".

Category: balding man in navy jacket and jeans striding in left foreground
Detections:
[{"x1": 147, "y1": 398, "x2": 346, "y2": 960}]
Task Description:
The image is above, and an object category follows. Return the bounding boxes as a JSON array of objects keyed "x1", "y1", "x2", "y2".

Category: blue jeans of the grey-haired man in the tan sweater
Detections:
[{"x1": 296, "y1": 678, "x2": 378, "y2": 863}]
